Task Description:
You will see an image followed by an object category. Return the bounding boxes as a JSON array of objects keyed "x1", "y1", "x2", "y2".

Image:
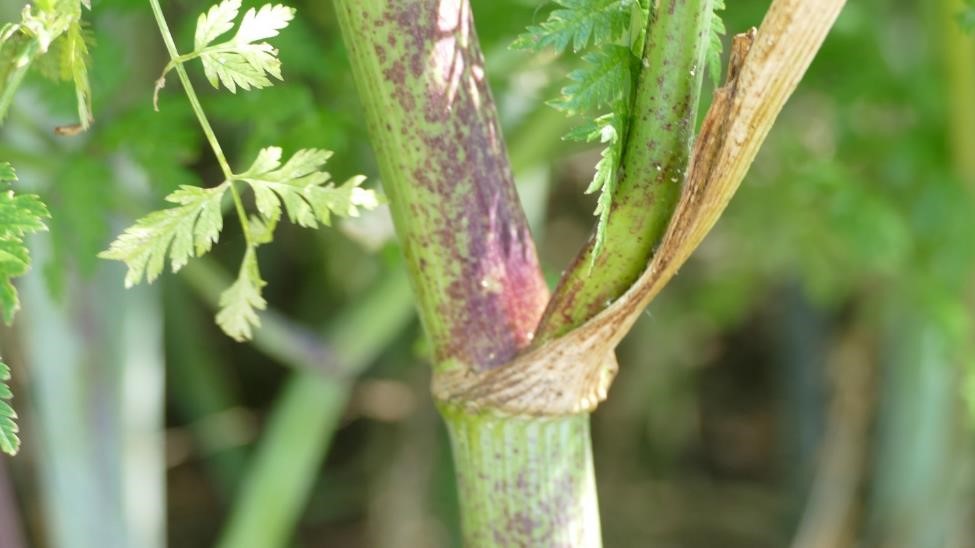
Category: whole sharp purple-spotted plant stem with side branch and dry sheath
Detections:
[{"x1": 335, "y1": 0, "x2": 844, "y2": 547}]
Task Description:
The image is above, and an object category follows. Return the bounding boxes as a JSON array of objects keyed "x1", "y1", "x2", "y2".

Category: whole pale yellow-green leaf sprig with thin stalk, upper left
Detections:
[{"x1": 100, "y1": 0, "x2": 379, "y2": 341}]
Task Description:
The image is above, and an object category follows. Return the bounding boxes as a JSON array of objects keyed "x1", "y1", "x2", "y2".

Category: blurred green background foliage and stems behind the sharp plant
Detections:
[{"x1": 0, "y1": 0, "x2": 975, "y2": 548}]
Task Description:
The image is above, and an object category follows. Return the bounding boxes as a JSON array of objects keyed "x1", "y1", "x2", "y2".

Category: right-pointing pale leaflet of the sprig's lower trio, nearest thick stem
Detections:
[{"x1": 237, "y1": 147, "x2": 379, "y2": 228}]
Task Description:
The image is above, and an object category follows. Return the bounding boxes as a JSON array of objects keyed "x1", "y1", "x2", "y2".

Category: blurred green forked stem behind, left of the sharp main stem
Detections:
[{"x1": 179, "y1": 259, "x2": 413, "y2": 548}]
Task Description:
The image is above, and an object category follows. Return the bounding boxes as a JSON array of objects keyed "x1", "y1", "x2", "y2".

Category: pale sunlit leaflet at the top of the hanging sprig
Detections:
[{"x1": 193, "y1": 0, "x2": 295, "y2": 93}]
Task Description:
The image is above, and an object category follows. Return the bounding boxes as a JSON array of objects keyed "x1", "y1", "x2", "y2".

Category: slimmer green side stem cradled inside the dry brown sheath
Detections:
[{"x1": 535, "y1": 0, "x2": 714, "y2": 343}]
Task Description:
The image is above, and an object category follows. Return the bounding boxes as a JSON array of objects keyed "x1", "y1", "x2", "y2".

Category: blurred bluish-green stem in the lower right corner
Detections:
[{"x1": 866, "y1": 311, "x2": 972, "y2": 548}]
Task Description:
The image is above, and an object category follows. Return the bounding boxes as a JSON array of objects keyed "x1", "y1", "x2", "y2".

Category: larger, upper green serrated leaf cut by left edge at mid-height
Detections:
[{"x1": 0, "y1": 162, "x2": 50, "y2": 324}]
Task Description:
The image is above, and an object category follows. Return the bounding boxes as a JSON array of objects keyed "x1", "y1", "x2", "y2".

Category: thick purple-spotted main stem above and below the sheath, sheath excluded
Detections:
[{"x1": 335, "y1": 0, "x2": 599, "y2": 547}]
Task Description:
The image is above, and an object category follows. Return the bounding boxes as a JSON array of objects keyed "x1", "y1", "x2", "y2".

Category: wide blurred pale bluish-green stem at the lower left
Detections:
[{"x1": 18, "y1": 239, "x2": 166, "y2": 548}]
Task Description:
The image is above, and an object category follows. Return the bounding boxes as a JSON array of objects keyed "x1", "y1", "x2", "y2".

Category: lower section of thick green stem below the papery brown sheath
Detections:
[{"x1": 441, "y1": 406, "x2": 602, "y2": 548}]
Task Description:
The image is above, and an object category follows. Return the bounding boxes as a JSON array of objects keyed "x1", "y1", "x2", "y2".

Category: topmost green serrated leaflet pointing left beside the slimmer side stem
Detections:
[{"x1": 512, "y1": 0, "x2": 636, "y2": 53}]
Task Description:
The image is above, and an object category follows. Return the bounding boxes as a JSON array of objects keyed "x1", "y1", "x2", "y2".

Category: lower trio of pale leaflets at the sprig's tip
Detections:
[{"x1": 99, "y1": 147, "x2": 379, "y2": 341}]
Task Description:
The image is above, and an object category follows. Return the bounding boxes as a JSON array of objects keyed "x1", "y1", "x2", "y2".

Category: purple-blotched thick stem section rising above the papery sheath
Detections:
[{"x1": 335, "y1": 0, "x2": 548, "y2": 370}]
